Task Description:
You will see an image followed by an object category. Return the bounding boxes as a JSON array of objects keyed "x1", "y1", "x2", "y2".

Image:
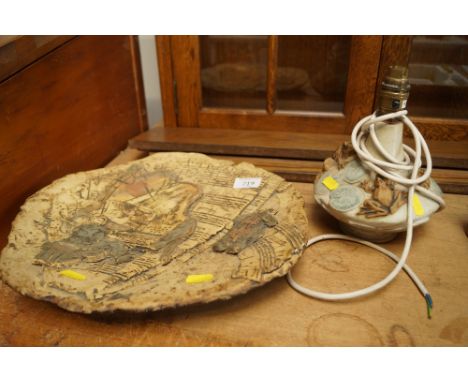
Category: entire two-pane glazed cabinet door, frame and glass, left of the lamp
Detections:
[{"x1": 163, "y1": 35, "x2": 382, "y2": 133}]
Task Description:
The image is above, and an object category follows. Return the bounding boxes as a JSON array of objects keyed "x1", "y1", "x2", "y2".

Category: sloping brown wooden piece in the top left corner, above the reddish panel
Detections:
[{"x1": 0, "y1": 36, "x2": 74, "y2": 81}]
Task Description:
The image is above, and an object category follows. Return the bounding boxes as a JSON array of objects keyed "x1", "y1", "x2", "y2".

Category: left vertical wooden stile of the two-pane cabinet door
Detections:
[{"x1": 171, "y1": 36, "x2": 201, "y2": 127}]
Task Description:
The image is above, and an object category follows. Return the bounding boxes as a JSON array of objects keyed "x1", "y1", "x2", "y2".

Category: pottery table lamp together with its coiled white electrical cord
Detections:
[{"x1": 288, "y1": 66, "x2": 445, "y2": 317}]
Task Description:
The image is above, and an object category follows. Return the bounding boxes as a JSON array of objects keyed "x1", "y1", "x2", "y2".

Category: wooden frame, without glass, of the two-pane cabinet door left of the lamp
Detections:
[{"x1": 156, "y1": 36, "x2": 382, "y2": 134}]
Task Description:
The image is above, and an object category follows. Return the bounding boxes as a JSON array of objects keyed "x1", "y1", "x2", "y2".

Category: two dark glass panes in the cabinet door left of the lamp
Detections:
[{"x1": 200, "y1": 36, "x2": 351, "y2": 113}]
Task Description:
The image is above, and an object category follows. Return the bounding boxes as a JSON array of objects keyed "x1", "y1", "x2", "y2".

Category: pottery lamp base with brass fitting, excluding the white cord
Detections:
[{"x1": 314, "y1": 67, "x2": 442, "y2": 242}]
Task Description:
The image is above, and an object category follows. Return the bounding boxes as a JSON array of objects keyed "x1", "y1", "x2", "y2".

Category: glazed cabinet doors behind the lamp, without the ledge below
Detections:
[{"x1": 157, "y1": 36, "x2": 468, "y2": 140}]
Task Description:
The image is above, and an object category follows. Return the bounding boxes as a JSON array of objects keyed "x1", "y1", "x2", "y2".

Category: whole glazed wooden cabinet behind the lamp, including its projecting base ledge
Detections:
[{"x1": 130, "y1": 36, "x2": 468, "y2": 192}]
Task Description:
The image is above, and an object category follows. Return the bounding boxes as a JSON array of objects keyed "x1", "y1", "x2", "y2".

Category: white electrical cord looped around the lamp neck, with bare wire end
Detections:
[{"x1": 287, "y1": 110, "x2": 445, "y2": 318}]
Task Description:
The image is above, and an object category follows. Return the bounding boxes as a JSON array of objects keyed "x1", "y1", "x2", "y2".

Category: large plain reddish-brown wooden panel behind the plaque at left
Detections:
[{"x1": 0, "y1": 36, "x2": 146, "y2": 249}]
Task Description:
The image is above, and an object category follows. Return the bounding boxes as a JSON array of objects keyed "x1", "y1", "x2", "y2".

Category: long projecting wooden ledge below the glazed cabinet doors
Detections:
[{"x1": 130, "y1": 127, "x2": 468, "y2": 169}]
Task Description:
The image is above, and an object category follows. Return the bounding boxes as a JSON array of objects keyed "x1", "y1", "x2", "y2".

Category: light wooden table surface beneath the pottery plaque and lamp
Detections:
[{"x1": 0, "y1": 154, "x2": 468, "y2": 346}]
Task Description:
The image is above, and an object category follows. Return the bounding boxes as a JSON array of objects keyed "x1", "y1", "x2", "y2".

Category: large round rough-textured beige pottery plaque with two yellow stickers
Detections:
[{"x1": 0, "y1": 153, "x2": 307, "y2": 313}]
